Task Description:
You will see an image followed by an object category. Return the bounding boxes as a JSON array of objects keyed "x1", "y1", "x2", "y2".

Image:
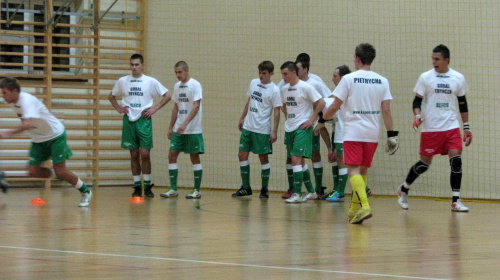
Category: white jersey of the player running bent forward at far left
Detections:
[{"x1": 11, "y1": 91, "x2": 64, "y2": 143}]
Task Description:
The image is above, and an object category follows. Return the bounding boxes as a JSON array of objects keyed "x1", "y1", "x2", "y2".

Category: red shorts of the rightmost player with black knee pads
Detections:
[{"x1": 420, "y1": 128, "x2": 463, "y2": 157}]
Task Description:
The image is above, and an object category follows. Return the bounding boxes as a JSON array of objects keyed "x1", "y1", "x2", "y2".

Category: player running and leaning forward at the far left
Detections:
[{"x1": 0, "y1": 78, "x2": 93, "y2": 207}]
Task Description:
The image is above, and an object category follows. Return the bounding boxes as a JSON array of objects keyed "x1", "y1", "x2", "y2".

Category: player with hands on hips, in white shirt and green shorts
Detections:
[{"x1": 108, "y1": 54, "x2": 171, "y2": 197}]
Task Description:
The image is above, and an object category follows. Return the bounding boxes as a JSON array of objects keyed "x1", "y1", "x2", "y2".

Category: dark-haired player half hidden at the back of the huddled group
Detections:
[{"x1": 296, "y1": 60, "x2": 332, "y2": 196}]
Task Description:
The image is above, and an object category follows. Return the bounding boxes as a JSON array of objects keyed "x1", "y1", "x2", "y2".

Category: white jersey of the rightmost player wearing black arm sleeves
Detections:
[{"x1": 413, "y1": 68, "x2": 469, "y2": 132}]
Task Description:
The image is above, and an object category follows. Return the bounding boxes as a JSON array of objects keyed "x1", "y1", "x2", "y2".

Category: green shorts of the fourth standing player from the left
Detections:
[{"x1": 285, "y1": 127, "x2": 314, "y2": 158}]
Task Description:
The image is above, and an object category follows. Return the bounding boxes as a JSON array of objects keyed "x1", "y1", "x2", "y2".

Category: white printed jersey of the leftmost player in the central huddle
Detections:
[{"x1": 243, "y1": 79, "x2": 282, "y2": 134}]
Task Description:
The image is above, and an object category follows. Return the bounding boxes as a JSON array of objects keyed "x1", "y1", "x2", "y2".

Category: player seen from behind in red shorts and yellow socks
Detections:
[{"x1": 323, "y1": 43, "x2": 399, "y2": 224}]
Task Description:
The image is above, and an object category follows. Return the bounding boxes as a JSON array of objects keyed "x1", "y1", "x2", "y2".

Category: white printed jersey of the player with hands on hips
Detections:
[{"x1": 111, "y1": 75, "x2": 168, "y2": 122}]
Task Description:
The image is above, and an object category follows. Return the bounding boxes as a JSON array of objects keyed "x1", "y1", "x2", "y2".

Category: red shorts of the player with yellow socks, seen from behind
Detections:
[{"x1": 344, "y1": 141, "x2": 378, "y2": 167}]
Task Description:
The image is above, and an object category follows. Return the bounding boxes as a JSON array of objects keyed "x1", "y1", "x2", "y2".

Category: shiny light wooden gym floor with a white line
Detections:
[{"x1": 0, "y1": 187, "x2": 500, "y2": 280}]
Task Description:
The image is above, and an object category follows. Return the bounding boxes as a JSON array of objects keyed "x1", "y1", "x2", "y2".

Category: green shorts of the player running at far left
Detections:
[{"x1": 28, "y1": 131, "x2": 73, "y2": 165}]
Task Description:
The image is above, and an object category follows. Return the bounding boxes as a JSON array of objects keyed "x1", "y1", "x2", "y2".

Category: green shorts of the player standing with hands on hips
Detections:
[{"x1": 122, "y1": 115, "x2": 153, "y2": 150}]
